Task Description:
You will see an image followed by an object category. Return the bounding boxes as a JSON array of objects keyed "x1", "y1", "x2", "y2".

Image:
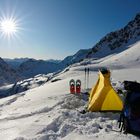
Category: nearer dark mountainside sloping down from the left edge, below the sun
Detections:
[{"x1": 0, "y1": 58, "x2": 21, "y2": 86}]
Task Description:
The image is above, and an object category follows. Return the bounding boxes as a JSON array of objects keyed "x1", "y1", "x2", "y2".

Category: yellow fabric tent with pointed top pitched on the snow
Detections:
[{"x1": 88, "y1": 71, "x2": 123, "y2": 111}]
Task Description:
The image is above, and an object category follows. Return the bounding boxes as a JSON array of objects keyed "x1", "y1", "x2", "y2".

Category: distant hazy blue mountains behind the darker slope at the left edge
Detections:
[{"x1": 1, "y1": 58, "x2": 64, "y2": 79}]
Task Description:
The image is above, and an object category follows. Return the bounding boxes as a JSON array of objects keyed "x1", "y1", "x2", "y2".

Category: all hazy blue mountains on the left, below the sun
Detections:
[{"x1": 0, "y1": 58, "x2": 64, "y2": 86}]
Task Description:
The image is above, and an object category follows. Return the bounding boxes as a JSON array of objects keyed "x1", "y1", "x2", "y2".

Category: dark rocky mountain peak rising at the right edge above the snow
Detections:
[{"x1": 84, "y1": 13, "x2": 140, "y2": 58}]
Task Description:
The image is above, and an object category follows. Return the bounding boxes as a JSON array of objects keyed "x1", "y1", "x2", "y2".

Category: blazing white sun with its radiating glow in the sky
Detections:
[{"x1": 0, "y1": 7, "x2": 23, "y2": 41}]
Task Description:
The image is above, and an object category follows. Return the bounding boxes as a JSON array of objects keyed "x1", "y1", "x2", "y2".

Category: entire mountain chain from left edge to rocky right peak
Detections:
[{"x1": 0, "y1": 13, "x2": 140, "y2": 85}]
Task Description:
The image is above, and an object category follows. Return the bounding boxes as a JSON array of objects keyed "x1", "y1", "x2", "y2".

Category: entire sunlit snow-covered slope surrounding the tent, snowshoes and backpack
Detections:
[{"x1": 0, "y1": 39, "x2": 140, "y2": 140}]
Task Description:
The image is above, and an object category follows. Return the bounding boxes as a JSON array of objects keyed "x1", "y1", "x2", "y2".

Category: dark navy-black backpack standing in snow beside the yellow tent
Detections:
[{"x1": 119, "y1": 81, "x2": 140, "y2": 135}]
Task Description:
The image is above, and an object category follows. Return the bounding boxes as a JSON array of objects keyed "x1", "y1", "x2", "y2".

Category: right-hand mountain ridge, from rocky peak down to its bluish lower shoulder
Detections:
[{"x1": 62, "y1": 13, "x2": 140, "y2": 65}]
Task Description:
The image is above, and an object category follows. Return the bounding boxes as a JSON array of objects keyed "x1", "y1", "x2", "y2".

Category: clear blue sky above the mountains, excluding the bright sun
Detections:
[{"x1": 0, "y1": 0, "x2": 140, "y2": 59}]
